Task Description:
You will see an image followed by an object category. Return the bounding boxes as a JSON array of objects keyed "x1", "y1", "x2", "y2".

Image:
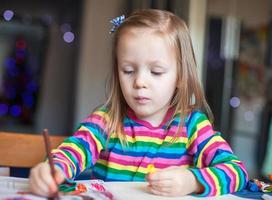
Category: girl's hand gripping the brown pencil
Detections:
[{"x1": 29, "y1": 162, "x2": 65, "y2": 197}]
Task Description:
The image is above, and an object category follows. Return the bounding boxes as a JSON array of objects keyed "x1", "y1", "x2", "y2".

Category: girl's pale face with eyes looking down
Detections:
[{"x1": 117, "y1": 28, "x2": 177, "y2": 126}]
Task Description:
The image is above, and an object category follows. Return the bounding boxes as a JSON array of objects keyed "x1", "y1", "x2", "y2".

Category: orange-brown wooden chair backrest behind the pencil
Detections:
[{"x1": 0, "y1": 132, "x2": 67, "y2": 168}]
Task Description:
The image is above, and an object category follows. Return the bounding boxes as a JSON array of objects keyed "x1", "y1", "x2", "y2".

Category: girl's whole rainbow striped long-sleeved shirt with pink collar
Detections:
[{"x1": 53, "y1": 108, "x2": 248, "y2": 196}]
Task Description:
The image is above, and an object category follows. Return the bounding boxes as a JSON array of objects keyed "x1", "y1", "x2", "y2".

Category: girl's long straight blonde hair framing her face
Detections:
[{"x1": 105, "y1": 9, "x2": 213, "y2": 145}]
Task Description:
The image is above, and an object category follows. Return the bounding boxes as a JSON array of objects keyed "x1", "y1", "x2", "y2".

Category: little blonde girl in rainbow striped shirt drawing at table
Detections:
[{"x1": 30, "y1": 10, "x2": 248, "y2": 196}]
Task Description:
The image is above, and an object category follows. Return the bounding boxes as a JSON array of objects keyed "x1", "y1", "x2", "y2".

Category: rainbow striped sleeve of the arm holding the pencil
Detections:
[{"x1": 52, "y1": 110, "x2": 107, "y2": 179}]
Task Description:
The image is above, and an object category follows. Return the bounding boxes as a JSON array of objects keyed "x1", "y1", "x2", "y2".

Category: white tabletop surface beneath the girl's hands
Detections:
[{"x1": 0, "y1": 176, "x2": 245, "y2": 200}]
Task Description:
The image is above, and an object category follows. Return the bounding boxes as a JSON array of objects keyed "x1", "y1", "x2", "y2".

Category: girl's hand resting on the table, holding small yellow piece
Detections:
[{"x1": 146, "y1": 166, "x2": 202, "y2": 196}]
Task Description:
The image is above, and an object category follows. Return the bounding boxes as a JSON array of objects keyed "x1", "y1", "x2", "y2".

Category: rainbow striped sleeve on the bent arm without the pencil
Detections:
[{"x1": 186, "y1": 112, "x2": 248, "y2": 196}]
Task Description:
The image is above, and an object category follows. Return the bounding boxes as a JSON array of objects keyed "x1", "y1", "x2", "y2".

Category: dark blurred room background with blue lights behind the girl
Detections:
[{"x1": 0, "y1": 0, "x2": 272, "y2": 180}]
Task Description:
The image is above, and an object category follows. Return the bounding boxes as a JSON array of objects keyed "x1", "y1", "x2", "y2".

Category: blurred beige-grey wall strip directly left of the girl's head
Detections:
[{"x1": 74, "y1": 0, "x2": 126, "y2": 126}]
